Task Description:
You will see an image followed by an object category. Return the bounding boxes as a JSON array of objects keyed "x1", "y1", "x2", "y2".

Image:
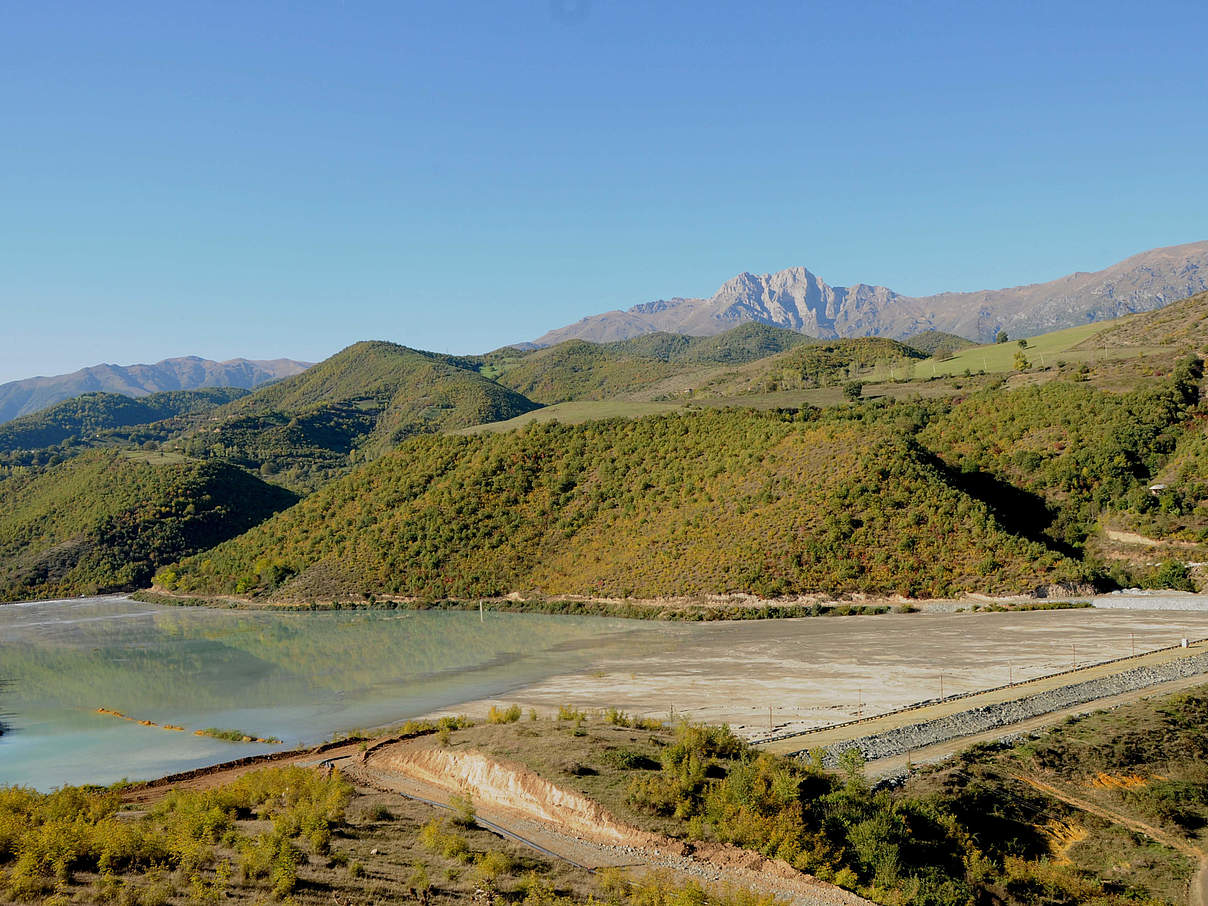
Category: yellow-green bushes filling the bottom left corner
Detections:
[{"x1": 0, "y1": 767, "x2": 353, "y2": 904}]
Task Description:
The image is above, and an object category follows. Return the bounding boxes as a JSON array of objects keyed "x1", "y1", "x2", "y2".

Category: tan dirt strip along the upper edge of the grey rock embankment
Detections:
[{"x1": 759, "y1": 641, "x2": 1208, "y2": 755}]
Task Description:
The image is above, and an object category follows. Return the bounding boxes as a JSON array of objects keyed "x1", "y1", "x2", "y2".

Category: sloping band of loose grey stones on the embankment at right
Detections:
[{"x1": 798, "y1": 655, "x2": 1208, "y2": 766}]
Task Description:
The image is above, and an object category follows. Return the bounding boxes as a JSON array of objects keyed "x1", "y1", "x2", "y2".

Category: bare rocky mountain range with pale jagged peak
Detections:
[{"x1": 535, "y1": 242, "x2": 1208, "y2": 345}]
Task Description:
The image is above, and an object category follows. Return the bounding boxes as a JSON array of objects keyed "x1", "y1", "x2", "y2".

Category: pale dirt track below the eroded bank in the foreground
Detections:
[{"x1": 352, "y1": 744, "x2": 870, "y2": 906}]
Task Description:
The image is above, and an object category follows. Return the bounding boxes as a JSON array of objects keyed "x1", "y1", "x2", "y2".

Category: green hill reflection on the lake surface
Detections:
[{"x1": 0, "y1": 600, "x2": 632, "y2": 710}]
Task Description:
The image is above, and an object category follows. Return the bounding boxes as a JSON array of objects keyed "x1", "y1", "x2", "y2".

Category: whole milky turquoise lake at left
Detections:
[{"x1": 0, "y1": 597, "x2": 658, "y2": 790}]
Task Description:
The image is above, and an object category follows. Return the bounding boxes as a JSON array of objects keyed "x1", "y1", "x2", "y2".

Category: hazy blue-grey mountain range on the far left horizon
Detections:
[{"x1": 0, "y1": 355, "x2": 310, "y2": 422}]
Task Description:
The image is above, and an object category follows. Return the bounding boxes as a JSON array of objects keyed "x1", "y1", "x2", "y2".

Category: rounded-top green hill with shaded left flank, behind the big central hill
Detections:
[{"x1": 174, "y1": 341, "x2": 538, "y2": 490}]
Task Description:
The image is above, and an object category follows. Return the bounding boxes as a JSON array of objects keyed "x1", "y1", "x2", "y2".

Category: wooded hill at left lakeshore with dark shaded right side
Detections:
[{"x1": 0, "y1": 449, "x2": 297, "y2": 600}]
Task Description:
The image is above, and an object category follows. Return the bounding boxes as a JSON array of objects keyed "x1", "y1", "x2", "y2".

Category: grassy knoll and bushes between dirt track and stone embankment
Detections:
[{"x1": 430, "y1": 689, "x2": 1208, "y2": 906}]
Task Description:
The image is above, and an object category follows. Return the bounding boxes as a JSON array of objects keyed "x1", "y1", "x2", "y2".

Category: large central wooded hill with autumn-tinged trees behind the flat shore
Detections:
[{"x1": 162, "y1": 347, "x2": 1203, "y2": 600}]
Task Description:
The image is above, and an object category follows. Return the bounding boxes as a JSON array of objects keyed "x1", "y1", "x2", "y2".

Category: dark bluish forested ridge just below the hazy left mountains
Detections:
[{"x1": 0, "y1": 387, "x2": 249, "y2": 453}]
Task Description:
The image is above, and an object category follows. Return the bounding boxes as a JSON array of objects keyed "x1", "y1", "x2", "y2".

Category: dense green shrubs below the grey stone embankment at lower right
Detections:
[{"x1": 628, "y1": 696, "x2": 1208, "y2": 906}]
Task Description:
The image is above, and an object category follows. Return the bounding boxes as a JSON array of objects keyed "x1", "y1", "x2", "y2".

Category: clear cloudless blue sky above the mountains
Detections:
[{"x1": 0, "y1": 0, "x2": 1208, "y2": 381}]
